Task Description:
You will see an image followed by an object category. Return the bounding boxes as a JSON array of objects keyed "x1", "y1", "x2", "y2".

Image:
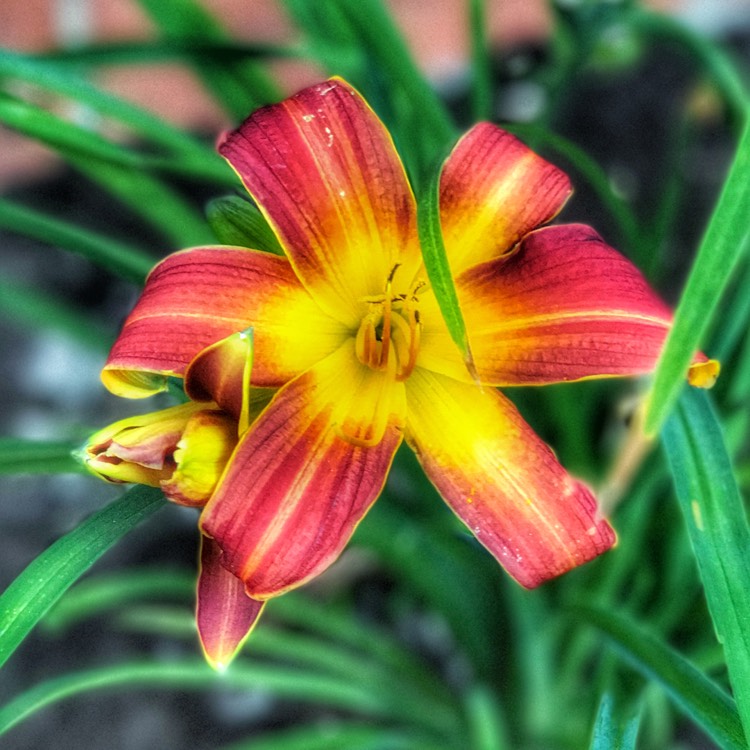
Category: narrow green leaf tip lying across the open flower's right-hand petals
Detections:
[{"x1": 417, "y1": 162, "x2": 476, "y2": 379}]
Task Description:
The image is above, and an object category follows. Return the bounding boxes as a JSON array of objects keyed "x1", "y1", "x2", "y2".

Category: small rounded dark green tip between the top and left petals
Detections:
[{"x1": 206, "y1": 195, "x2": 284, "y2": 255}]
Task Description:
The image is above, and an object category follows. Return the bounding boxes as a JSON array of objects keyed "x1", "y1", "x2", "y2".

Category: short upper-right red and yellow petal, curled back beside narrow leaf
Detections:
[{"x1": 440, "y1": 122, "x2": 572, "y2": 275}]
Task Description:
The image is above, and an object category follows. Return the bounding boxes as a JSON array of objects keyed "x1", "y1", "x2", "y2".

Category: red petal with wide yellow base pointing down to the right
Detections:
[{"x1": 406, "y1": 369, "x2": 615, "y2": 588}]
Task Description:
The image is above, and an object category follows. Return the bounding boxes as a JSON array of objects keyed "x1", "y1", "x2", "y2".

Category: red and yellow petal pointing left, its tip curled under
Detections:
[{"x1": 102, "y1": 247, "x2": 345, "y2": 398}]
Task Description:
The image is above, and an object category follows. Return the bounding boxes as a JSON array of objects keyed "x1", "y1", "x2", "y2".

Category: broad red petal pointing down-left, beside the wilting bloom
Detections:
[{"x1": 201, "y1": 341, "x2": 406, "y2": 599}]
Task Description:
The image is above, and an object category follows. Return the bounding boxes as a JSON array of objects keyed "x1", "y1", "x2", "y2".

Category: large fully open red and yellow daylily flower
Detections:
[{"x1": 102, "y1": 79, "x2": 714, "y2": 612}]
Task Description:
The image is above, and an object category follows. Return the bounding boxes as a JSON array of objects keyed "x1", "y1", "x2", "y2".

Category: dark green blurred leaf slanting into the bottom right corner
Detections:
[{"x1": 573, "y1": 606, "x2": 747, "y2": 750}]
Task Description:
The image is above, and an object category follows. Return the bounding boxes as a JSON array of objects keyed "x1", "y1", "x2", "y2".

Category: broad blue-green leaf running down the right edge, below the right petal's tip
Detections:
[{"x1": 662, "y1": 390, "x2": 750, "y2": 737}]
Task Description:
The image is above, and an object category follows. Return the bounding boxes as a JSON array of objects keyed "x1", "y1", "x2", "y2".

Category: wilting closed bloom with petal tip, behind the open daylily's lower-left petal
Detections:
[{"x1": 81, "y1": 402, "x2": 263, "y2": 668}]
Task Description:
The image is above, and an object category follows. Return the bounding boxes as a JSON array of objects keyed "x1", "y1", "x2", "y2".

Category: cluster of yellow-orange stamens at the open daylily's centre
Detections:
[{"x1": 355, "y1": 266, "x2": 424, "y2": 381}]
